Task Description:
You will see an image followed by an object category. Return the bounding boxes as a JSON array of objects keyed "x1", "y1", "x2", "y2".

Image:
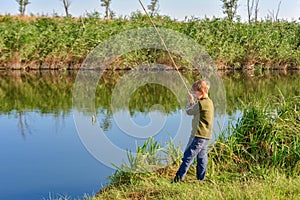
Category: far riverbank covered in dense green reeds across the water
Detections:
[{"x1": 0, "y1": 13, "x2": 300, "y2": 69}]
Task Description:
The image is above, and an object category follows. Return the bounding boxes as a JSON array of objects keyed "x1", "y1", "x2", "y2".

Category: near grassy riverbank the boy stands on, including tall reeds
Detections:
[{"x1": 94, "y1": 96, "x2": 300, "y2": 199}]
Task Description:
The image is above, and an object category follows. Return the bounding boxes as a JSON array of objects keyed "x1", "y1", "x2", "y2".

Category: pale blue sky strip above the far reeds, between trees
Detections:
[{"x1": 0, "y1": 0, "x2": 300, "y2": 21}]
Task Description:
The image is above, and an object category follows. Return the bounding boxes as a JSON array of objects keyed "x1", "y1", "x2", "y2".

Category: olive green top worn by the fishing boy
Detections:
[{"x1": 186, "y1": 98, "x2": 214, "y2": 139}]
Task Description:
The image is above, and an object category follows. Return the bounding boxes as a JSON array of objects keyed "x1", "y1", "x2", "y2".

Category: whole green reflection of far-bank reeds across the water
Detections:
[{"x1": 0, "y1": 71, "x2": 300, "y2": 133}]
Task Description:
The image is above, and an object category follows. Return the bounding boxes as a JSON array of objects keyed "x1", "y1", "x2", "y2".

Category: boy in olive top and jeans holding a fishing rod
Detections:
[{"x1": 173, "y1": 80, "x2": 214, "y2": 182}]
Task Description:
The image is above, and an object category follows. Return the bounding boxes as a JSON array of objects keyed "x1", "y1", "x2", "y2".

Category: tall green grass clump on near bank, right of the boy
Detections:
[{"x1": 211, "y1": 96, "x2": 300, "y2": 176}]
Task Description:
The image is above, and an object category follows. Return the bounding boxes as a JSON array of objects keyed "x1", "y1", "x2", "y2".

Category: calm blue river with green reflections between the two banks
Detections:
[{"x1": 0, "y1": 71, "x2": 300, "y2": 200}]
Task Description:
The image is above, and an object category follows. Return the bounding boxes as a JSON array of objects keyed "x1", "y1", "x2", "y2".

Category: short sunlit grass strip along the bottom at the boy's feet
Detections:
[{"x1": 94, "y1": 174, "x2": 300, "y2": 200}]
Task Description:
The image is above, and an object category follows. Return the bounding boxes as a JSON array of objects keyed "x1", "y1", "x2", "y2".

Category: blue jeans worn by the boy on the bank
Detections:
[{"x1": 176, "y1": 136, "x2": 209, "y2": 180}]
